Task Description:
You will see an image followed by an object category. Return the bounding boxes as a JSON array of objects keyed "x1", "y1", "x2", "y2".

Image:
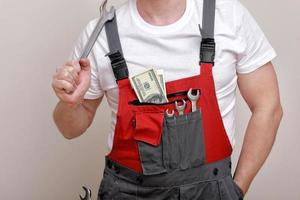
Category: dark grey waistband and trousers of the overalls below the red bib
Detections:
[{"x1": 98, "y1": 159, "x2": 239, "y2": 200}]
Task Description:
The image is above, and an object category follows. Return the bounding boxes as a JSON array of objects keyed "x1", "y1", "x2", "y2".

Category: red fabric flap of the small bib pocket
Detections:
[{"x1": 134, "y1": 112, "x2": 164, "y2": 146}]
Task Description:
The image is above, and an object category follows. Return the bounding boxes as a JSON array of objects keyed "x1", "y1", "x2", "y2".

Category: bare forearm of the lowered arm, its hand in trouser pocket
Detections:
[{"x1": 234, "y1": 106, "x2": 282, "y2": 193}]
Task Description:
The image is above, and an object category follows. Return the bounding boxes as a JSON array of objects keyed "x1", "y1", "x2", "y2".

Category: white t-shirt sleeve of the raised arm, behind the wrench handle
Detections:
[{"x1": 70, "y1": 20, "x2": 104, "y2": 99}]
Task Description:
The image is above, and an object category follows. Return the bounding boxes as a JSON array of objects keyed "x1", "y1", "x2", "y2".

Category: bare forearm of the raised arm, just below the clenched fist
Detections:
[{"x1": 53, "y1": 101, "x2": 90, "y2": 139}]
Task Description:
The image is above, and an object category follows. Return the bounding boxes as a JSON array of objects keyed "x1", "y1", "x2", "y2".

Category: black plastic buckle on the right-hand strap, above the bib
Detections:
[{"x1": 200, "y1": 38, "x2": 216, "y2": 65}]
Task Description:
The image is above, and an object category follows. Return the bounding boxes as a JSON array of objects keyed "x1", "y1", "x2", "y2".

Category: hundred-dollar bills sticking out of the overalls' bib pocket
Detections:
[{"x1": 129, "y1": 69, "x2": 168, "y2": 104}]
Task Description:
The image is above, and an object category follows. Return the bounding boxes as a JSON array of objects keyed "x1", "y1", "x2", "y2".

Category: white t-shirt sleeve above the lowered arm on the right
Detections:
[{"x1": 235, "y1": 1, "x2": 276, "y2": 74}]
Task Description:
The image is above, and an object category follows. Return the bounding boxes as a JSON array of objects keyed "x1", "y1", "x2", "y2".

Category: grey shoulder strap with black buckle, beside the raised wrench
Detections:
[{"x1": 105, "y1": 10, "x2": 129, "y2": 81}]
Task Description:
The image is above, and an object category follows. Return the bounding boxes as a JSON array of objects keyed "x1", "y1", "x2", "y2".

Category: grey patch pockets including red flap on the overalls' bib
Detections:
[{"x1": 133, "y1": 106, "x2": 205, "y2": 175}]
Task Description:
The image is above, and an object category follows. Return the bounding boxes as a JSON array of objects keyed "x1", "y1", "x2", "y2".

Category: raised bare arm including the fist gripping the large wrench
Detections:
[{"x1": 52, "y1": 59, "x2": 102, "y2": 139}]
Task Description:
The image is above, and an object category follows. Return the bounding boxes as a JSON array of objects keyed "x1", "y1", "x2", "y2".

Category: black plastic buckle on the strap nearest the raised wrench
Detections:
[{"x1": 107, "y1": 51, "x2": 129, "y2": 81}]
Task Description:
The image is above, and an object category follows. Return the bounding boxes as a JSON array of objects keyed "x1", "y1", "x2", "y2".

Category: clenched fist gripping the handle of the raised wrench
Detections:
[{"x1": 52, "y1": 59, "x2": 91, "y2": 105}]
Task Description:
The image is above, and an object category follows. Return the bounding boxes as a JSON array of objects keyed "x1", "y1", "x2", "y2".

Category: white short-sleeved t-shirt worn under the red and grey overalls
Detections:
[{"x1": 71, "y1": 0, "x2": 276, "y2": 149}]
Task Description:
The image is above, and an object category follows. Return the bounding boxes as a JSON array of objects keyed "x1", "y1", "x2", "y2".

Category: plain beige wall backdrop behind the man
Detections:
[{"x1": 0, "y1": 0, "x2": 300, "y2": 200}]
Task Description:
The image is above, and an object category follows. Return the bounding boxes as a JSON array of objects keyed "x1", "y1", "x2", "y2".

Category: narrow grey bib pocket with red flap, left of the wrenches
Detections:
[{"x1": 134, "y1": 112, "x2": 166, "y2": 175}]
